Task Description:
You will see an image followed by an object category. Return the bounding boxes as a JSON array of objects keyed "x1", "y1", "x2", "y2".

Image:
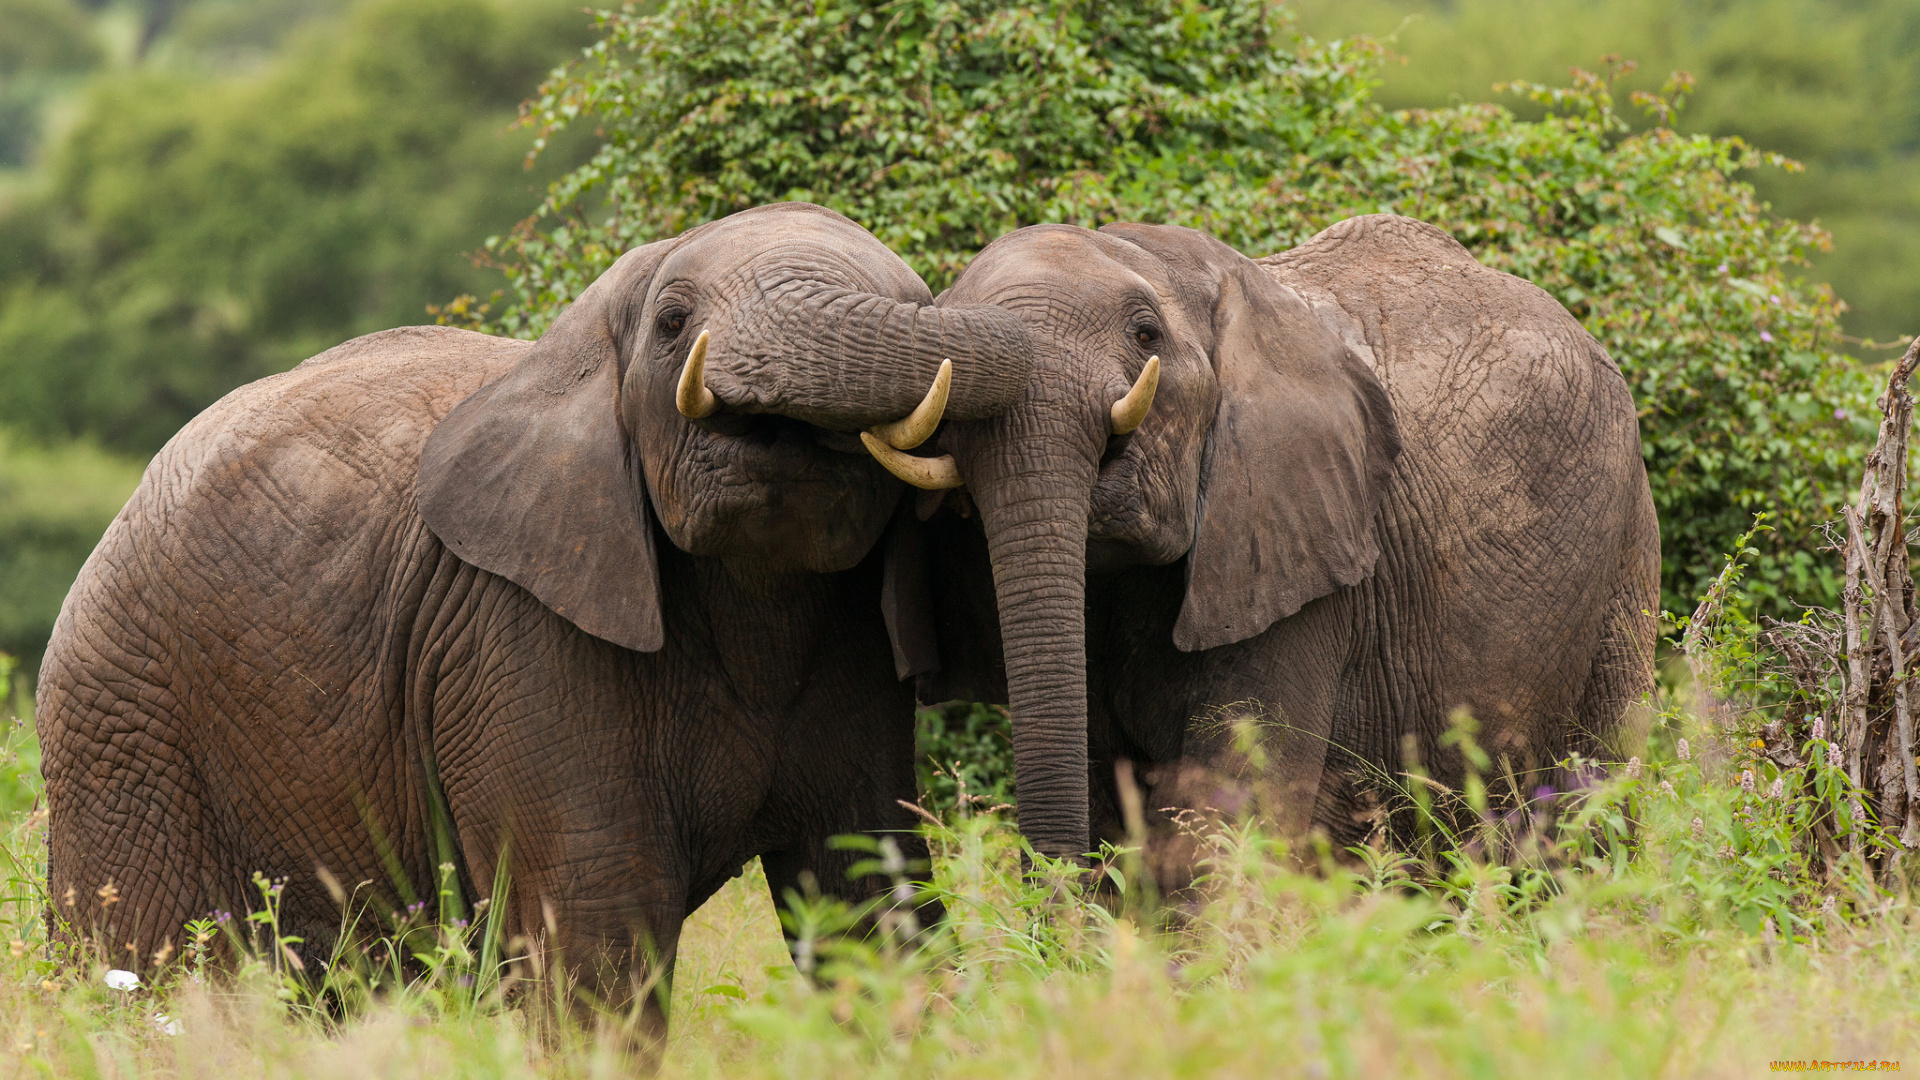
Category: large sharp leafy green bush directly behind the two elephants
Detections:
[{"x1": 480, "y1": 0, "x2": 1870, "y2": 607}]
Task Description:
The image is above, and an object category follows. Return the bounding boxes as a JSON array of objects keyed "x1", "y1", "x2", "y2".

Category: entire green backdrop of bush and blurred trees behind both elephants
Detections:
[{"x1": 0, "y1": 0, "x2": 1920, "y2": 675}]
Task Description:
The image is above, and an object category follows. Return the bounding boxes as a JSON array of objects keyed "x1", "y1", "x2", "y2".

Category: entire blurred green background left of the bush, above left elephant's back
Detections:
[{"x1": 0, "y1": 0, "x2": 591, "y2": 664}]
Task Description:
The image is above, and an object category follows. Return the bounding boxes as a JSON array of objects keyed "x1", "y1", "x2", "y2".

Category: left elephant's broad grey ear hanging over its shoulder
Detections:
[{"x1": 417, "y1": 240, "x2": 674, "y2": 651}]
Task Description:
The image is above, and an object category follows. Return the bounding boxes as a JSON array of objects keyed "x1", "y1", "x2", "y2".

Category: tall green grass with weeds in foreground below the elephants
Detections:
[{"x1": 0, "y1": 576, "x2": 1920, "y2": 1080}]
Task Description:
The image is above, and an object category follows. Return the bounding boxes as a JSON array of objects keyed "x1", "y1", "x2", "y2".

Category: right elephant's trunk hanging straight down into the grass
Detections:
[{"x1": 962, "y1": 417, "x2": 1098, "y2": 859}]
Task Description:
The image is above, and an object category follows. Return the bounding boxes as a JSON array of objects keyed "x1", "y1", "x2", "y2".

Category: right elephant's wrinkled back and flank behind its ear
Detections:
[{"x1": 1260, "y1": 215, "x2": 1659, "y2": 761}]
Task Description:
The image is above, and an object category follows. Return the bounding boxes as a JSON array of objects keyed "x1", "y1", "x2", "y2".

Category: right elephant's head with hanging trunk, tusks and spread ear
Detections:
[{"x1": 870, "y1": 225, "x2": 1400, "y2": 857}]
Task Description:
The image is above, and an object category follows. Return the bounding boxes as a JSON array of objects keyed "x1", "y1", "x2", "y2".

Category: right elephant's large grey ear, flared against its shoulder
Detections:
[{"x1": 1173, "y1": 255, "x2": 1400, "y2": 651}]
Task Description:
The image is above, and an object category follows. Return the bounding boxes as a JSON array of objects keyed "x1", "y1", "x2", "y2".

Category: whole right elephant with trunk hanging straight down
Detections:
[{"x1": 920, "y1": 215, "x2": 1659, "y2": 860}]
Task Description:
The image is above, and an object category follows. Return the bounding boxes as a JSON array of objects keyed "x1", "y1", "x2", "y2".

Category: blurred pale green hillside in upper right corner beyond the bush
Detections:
[{"x1": 1298, "y1": 0, "x2": 1920, "y2": 354}]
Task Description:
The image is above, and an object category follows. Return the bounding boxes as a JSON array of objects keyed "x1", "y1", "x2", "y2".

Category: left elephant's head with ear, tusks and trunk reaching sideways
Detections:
[{"x1": 417, "y1": 204, "x2": 1029, "y2": 651}]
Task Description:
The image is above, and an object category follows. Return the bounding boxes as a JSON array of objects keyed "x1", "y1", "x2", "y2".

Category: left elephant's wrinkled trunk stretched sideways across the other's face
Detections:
[{"x1": 707, "y1": 284, "x2": 1033, "y2": 430}]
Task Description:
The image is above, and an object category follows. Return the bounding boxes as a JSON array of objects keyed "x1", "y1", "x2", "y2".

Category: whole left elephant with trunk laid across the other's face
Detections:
[{"x1": 36, "y1": 204, "x2": 1027, "y2": 1024}]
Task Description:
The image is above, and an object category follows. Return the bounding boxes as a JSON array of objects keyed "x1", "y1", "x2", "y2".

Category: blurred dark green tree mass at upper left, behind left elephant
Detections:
[{"x1": 0, "y1": 0, "x2": 586, "y2": 454}]
